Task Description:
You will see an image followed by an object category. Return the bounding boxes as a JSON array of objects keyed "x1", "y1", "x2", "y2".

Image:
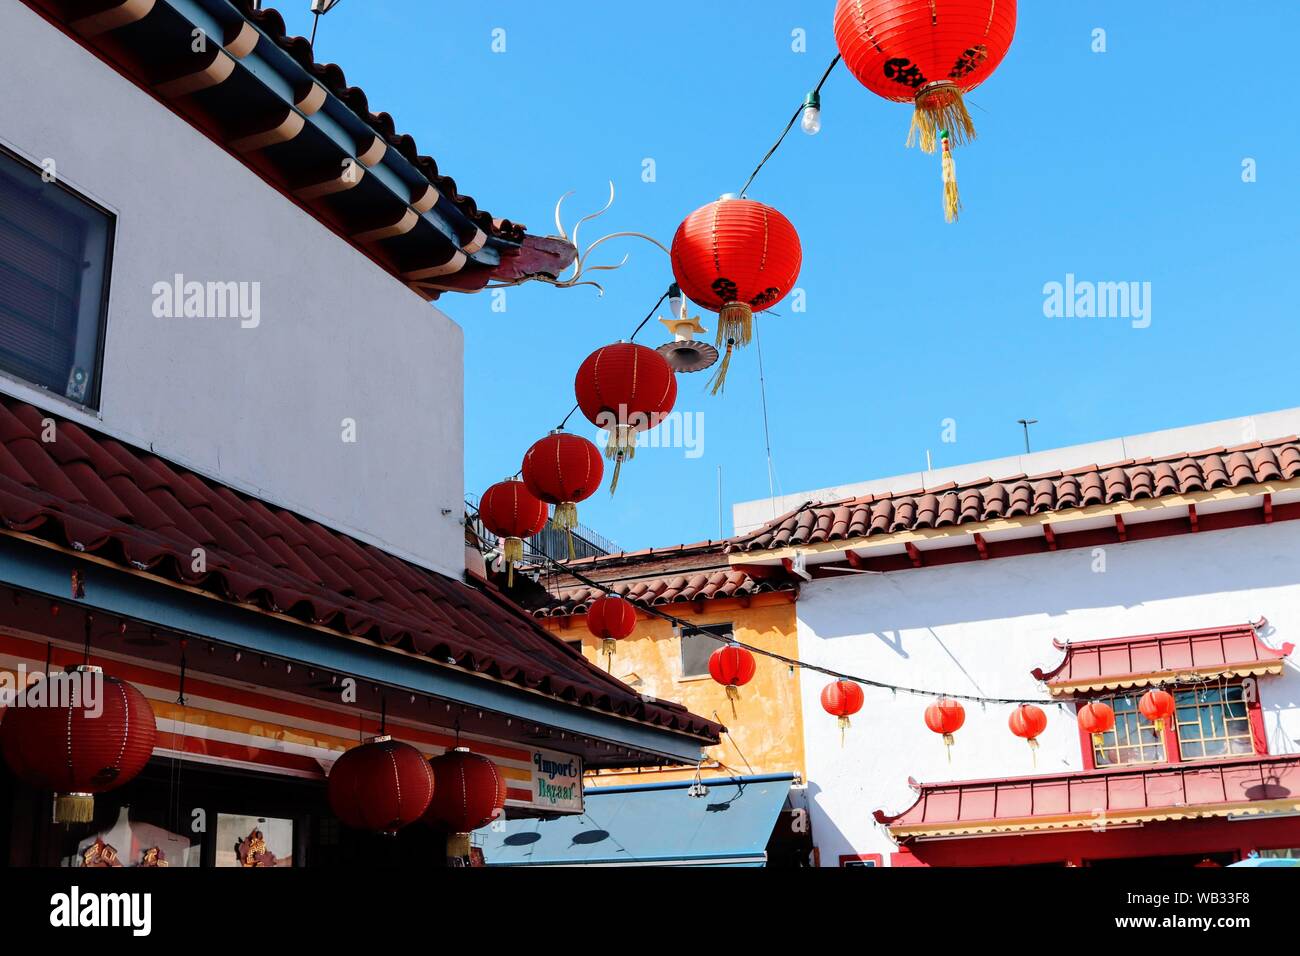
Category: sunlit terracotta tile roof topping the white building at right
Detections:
[{"x1": 729, "y1": 436, "x2": 1300, "y2": 551}]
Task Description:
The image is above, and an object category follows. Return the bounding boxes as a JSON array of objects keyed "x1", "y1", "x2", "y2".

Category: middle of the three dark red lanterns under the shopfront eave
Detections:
[{"x1": 326, "y1": 736, "x2": 433, "y2": 834}]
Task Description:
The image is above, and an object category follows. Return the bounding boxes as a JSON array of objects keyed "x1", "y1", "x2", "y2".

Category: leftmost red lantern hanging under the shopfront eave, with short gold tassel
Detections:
[{"x1": 0, "y1": 665, "x2": 157, "y2": 823}]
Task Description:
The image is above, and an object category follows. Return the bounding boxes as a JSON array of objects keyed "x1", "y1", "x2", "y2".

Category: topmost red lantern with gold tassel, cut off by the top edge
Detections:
[{"x1": 835, "y1": 0, "x2": 1015, "y2": 222}]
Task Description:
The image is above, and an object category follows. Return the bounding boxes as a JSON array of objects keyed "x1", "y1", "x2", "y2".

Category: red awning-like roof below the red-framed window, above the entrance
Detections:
[{"x1": 875, "y1": 754, "x2": 1300, "y2": 840}]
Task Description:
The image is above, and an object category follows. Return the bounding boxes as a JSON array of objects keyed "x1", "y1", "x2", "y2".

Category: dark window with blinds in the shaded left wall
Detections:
[{"x1": 0, "y1": 151, "x2": 113, "y2": 408}]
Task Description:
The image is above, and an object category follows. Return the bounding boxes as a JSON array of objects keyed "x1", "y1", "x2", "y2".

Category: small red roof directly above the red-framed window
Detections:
[{"x1": 1032, "y1": 620, "x2": 1295, "y2": 693}]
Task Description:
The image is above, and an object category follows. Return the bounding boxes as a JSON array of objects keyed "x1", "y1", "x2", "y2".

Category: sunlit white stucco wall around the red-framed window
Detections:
[{"x1": 797, "y1": 522, "x2": 1300, "y2": 866}]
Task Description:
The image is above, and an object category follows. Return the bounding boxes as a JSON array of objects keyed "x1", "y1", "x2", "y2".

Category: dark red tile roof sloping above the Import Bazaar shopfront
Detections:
[{"x1": 0, "y1": 395, "x2": 720, "y2": 743}]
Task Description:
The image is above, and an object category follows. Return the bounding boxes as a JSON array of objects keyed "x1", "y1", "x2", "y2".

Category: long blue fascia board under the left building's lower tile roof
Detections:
[{"x1": 0, "y1": 536, "x2": 705, "y2": 763}]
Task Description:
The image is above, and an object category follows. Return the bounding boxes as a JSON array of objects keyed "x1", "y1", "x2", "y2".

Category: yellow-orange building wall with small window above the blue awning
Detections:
[{"x1": 547, "y1": 593, "x2": 803, "y2": 786}]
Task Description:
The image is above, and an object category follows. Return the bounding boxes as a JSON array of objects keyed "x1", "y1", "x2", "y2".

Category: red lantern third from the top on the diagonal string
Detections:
[{"x1": 573, "y1": 342, "x2": 677, "y2": 494}]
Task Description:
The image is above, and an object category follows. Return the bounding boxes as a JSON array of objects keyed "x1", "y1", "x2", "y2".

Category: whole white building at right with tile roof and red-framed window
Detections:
[{"x1": 737, "y1": 411, "x2": 1300, "y2": 866}]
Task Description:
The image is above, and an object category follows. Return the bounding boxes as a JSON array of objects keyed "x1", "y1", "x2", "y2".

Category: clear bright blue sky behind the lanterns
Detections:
[{"x1": 276, "y1": 0, "x2": 1300, "y2": 549}]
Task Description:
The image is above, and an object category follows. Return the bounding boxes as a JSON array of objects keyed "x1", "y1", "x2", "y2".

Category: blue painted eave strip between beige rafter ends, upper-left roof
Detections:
[{"x1": 179, "y1": 0, "x2": 512, "y2": 268}]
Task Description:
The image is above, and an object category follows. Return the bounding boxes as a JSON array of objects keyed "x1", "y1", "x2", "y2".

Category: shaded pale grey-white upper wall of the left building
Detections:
[{"x1": 0, "y1": 0, "x2": 464, "y2": 576}]
